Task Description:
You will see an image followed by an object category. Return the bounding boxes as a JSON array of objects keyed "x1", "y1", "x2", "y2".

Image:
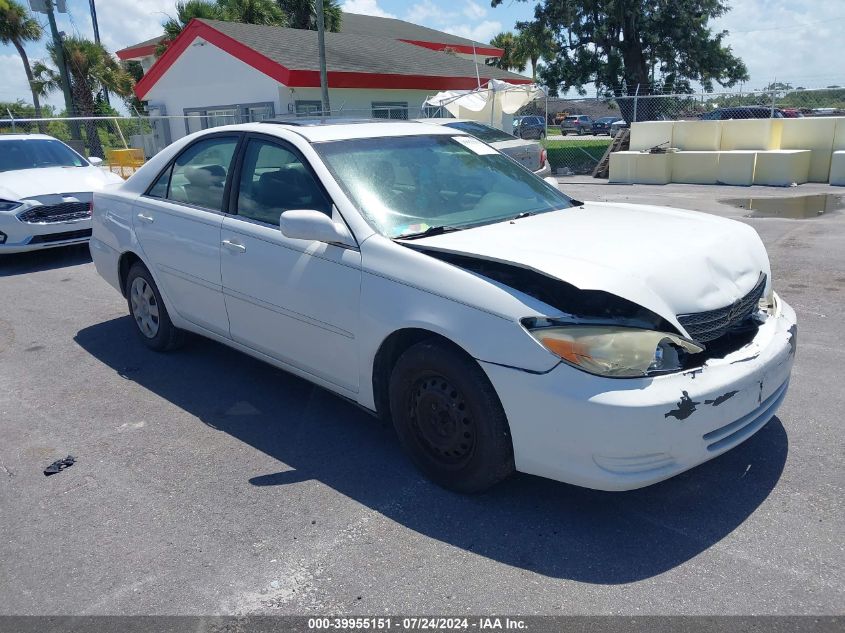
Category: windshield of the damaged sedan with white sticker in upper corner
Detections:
[{"x1": 314, "y1": 135, "x2": 573, "y2": 238}]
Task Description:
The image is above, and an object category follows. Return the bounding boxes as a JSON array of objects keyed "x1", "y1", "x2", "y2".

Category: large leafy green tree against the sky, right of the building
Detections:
[{"x1": 491, "y1": 0, "x2": 748, "y2": 100}]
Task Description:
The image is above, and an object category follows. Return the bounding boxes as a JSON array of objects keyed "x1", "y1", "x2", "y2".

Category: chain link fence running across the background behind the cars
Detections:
[{"x1": 0, "y1": 86, "x2": 845, "y2": 176}]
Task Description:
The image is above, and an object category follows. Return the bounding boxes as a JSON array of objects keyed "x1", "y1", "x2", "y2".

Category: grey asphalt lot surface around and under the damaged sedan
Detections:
[{"x1": 0, "y1": 177, "x2": 845, "y2": 615}]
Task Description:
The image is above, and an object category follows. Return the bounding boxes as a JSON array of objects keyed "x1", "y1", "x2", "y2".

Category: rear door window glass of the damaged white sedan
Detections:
[{"x1": 166, "y1": 137, "x2": 238, "y2": 211}]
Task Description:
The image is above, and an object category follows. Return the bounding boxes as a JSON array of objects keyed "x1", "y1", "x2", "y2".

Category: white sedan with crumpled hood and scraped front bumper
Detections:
[{"x1": 91, "y1": 120, "x2": 797, "y2": 491}]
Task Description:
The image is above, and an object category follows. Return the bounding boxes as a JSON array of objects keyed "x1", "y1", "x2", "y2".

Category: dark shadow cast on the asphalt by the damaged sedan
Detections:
[{"x1": 76, "y1": 317, "x2": 788, "y2": 584}]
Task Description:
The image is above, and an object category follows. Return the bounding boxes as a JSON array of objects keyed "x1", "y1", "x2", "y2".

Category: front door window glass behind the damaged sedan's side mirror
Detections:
[{"x1": 238, "y1": 140, "x2": 331, "y2": 225}]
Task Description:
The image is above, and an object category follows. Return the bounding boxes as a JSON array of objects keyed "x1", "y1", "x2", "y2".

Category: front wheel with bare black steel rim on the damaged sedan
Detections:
[{"x1": 390, "y1": 340, "x2": 514, "y2": 493}]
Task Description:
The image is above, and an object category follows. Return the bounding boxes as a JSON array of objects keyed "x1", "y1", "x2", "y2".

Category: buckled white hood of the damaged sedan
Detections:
[{"x1": 416, "y1": 202, "x2": 771, "y2": 329}]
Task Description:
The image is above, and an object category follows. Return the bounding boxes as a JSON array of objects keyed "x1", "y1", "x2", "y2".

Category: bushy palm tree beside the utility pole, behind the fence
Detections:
[{"x1": 33, "y1": 37, "x2": 135, "y2": 156}]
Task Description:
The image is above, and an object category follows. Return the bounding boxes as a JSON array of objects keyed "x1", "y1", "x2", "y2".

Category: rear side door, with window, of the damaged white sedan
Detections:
[{"x1": 132, "y1": 133, "x2": 241, "y2": 337}]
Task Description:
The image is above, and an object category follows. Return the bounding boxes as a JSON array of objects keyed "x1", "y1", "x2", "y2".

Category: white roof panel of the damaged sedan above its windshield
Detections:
[{"x1": 237, "y1": 118, "x2": 463, "y2": 142}]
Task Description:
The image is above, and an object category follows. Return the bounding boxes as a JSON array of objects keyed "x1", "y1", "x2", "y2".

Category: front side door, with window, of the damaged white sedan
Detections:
[{"x1": 221, "y1": 136, "x2": 361, "y2": 392}]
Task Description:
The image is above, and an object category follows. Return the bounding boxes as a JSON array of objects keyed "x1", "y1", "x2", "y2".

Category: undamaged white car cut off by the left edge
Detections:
[{"x1": 0, "y1": 134, "x2": 123, "y2": 254}]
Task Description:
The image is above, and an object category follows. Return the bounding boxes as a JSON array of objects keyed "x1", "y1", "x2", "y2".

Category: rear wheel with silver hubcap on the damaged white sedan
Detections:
[{"x1": 126, "y1": 262, "x2": 185, "y2": 352}]
